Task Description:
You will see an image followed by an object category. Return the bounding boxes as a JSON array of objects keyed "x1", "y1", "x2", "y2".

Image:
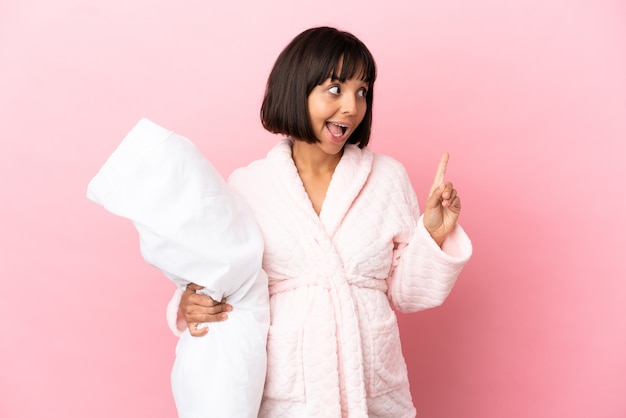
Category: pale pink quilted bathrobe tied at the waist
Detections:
[{"x1": 168, "y1": 140, "x2": 472, "y2": 418}]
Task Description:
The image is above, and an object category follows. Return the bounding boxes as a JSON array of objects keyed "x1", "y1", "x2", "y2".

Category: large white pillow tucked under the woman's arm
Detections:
[{"x1": 87, "y1": 119, "x2": 269, "y2": 417}]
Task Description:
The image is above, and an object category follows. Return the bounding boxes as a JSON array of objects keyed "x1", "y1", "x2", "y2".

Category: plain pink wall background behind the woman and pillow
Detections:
[{"x1": 0, "y1": 0, "x2": 626, "y2": 418}]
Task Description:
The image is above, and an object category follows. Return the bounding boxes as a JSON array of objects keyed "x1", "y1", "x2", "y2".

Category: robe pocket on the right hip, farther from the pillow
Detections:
[{"x1": 365, "y1": 312, "x2": 408, "y2": 398}]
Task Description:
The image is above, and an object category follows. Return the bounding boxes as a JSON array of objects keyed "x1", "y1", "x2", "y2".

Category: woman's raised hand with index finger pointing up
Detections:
[{"x1": 424, "y1": 152, "x2": 461, "y2": 246}]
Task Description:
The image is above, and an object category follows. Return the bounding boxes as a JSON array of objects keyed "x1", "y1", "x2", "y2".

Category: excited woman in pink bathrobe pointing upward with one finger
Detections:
[{"x1": 169, "y1": 27, "x2": 472, "y2": 418}]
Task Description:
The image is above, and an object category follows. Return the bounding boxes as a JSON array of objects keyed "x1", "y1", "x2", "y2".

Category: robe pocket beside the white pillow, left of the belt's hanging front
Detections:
[{"x1": 264, "y1": 325, "x2": 305, "y2": 402}]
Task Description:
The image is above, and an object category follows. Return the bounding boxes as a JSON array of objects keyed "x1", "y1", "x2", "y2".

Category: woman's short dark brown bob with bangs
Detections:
[{"x1": 261, "y1": 27, "x2": 376, "y2": 148}]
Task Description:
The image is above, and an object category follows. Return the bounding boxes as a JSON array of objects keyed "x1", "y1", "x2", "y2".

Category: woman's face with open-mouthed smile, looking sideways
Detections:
[{"x1": 308, "y1": 78, "x2": 369, "y2": 154}]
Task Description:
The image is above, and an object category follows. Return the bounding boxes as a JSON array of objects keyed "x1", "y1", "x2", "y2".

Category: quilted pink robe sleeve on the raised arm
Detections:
[{"x1": 387, "y1": 162, "x2": 472, "y2": 312}]
